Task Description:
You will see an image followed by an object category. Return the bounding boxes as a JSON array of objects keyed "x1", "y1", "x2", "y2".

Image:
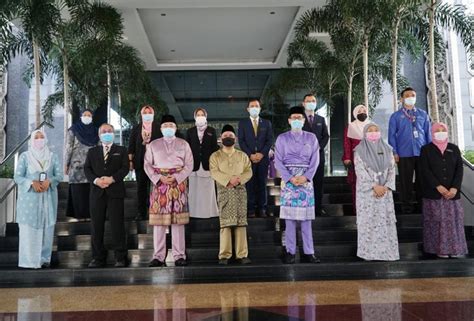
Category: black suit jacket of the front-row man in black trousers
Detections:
[{"x1": 84, "y1": 144, "x2": 129, "y2": 198}]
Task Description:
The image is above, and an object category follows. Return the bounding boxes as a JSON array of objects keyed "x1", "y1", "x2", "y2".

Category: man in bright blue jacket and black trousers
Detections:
[{"x1": 388, "y1": 87, "x2": 431, "y2": 213}]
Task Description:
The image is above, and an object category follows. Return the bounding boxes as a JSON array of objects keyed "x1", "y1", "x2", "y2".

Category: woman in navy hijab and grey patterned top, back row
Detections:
[{"x1": 64, "y1": 109, "x2": 99, "y2": 220}]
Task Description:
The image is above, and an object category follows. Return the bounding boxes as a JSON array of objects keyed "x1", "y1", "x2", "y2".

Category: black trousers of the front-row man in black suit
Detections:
[{"x1": 90, "y1": 193, "x2": 127, "y2": 261}]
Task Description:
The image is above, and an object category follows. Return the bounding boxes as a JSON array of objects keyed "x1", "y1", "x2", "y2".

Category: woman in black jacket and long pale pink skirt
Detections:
[{"x1": 186, "y1": 108, "x2": 219, "y2": 218}]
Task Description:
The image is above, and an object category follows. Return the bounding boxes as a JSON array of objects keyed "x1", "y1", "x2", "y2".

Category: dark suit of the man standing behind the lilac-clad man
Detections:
[{"x1": 303, "y1": 113, "x2": 329, "y2": 215}]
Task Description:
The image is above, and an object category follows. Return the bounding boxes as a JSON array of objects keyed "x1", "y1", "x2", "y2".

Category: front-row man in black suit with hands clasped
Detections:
[{"x1": 84, "y1": 124, "x2": 129, "y2": 268}]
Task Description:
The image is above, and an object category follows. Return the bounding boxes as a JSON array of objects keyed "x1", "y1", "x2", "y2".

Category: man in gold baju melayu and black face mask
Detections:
[{"x1": 209, "y1": 125, "x2": 252, "y2": 265}]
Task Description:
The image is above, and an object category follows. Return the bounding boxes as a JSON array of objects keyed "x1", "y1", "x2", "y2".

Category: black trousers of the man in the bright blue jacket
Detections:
[{"x1": 398, "y1": 157, "x2": 421, "y2": 208}]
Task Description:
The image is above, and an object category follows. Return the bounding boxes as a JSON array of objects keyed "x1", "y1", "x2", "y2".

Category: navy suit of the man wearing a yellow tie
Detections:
[{"x1": 238, "y1": 117, "x2": 273, "y2": 213}]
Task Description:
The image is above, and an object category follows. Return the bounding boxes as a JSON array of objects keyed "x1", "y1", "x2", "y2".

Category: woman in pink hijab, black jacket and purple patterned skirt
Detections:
[{"x1": 420, "y1": 123, "x2": 468, "y2": 258}]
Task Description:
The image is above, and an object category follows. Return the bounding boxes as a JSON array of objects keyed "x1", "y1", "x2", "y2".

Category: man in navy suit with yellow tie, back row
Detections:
[{"x1": 238, "y1": 99, "x2": 273, "y2": 217}]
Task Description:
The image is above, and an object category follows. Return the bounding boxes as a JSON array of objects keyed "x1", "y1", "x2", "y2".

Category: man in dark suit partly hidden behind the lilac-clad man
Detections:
[{"x1": 303, "y1": 94, "x2": 329, "y2": 215}]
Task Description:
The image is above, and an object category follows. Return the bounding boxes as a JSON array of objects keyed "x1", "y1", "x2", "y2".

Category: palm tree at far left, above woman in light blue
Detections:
[{"x1": 0, "y1": 0, "x2": 60, "y2": 126}]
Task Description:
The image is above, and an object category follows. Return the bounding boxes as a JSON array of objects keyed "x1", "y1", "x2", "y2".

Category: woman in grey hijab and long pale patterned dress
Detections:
[{"x1": 354, "y1": 123, "x2": 400, "y2": 261}]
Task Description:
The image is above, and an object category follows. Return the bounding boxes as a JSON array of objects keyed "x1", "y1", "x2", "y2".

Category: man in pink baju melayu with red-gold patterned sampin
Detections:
[{"x1": 144, "y1": 115, "x2": 194, "y2": 267}]
